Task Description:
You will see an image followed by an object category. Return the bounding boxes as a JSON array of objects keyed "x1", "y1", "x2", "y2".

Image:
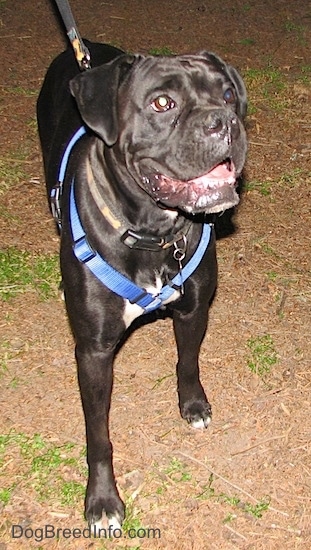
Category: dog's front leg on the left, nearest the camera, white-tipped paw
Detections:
[{"x1": 76, "y1": 345, "x2": 124, "y2": 536}]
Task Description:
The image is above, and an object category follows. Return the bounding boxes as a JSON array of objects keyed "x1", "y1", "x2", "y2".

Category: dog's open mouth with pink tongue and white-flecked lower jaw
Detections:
[{"x1": 144, "y1": 159, "x2": 239, "y2": 213}]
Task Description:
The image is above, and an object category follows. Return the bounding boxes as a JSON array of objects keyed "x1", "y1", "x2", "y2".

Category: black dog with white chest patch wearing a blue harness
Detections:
[{"x1": 38, "y1": 43, "x2": 246, "y2": 531}]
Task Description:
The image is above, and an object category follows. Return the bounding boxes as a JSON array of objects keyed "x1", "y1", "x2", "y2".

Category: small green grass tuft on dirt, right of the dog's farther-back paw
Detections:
[{"x1": 246, "y1": 334, "x2": 277, "y2": 377}]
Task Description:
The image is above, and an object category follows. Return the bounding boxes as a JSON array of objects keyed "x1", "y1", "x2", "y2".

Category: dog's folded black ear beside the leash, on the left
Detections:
[{"x1": 69, "y1": 54, "x2": 139, "y2": 146}]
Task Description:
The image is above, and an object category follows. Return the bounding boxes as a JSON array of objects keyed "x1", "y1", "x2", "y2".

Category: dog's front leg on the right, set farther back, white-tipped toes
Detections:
[{"x1": 173, "y1": 307, "x2": 212, "y2": 428}]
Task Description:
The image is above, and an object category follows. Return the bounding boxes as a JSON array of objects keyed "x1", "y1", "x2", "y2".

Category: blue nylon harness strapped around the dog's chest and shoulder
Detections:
[{"x1": 51, "y1": 127, "x2": 211, "y2": 313}]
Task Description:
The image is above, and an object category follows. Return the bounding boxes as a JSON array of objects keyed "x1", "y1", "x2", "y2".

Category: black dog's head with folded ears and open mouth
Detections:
[{"x1": 70, "y1": 52, "x2": 247, "y2": 213}]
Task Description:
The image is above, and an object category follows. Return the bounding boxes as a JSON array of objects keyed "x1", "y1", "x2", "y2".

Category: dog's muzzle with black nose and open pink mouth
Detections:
[{"x1": 142, "y1": 109, "x2": 246, "y2": 214}]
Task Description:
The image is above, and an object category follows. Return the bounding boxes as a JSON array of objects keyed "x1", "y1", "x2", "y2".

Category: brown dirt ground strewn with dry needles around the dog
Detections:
[{"x1": 0, "y1": 0, "x2": 311, "y2": 550}]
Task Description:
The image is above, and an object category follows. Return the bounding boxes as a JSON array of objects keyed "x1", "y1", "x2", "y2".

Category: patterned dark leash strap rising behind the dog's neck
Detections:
[{"x1": 55, "y1": 0, "x2": 91, "y2": 71}]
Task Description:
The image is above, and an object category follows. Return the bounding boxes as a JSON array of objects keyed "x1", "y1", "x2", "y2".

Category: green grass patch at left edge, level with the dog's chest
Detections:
[{"x1": 0, "y1": 248, "x2": 60, "y2": 300}]
